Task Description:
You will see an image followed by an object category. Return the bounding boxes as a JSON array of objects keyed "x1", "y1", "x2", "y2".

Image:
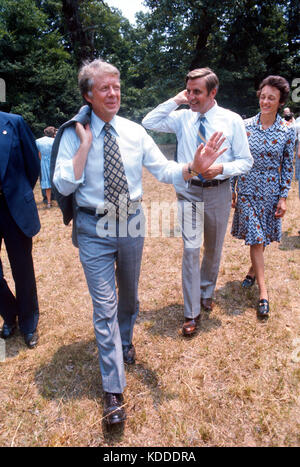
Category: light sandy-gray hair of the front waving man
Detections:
[{"x1": 78, "y1": 58, "x2": 120, "y2": 97}]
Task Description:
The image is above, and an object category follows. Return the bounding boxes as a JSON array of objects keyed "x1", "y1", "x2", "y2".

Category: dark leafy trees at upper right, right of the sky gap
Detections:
[{"x1": 144, "y1": 0, "x2": 300, "y2": 115}]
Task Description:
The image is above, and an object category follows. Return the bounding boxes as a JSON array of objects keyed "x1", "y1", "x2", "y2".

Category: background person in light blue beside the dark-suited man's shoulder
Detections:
[{"x1": 36, "y1": 126, "x2": 56, "y2": 209}]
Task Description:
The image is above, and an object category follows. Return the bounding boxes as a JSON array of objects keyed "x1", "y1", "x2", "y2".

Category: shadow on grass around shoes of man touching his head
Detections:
[{"x1": 137, "y1": 303, "x2": 221, "y2": 339}]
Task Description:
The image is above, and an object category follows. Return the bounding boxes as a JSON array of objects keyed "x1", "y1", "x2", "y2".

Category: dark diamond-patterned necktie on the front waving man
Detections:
[{"x1": 104, "y1": 123, "x2": 130, "y2": 220}]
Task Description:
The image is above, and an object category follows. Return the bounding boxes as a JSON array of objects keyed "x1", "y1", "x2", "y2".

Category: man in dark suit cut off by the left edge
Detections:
[{"x1": 0, "y1": 112, "x2": 40, "y2": 348}]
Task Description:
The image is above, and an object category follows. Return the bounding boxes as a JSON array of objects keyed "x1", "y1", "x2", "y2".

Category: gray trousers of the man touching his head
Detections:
[{"x1": 178, "y1": 180, "x2": 231, "y2": 318}]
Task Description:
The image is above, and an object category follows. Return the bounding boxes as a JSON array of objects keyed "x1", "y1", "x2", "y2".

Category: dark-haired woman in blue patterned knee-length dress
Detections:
[{"x1": 231, "y1": 76, "x2": 295, "y2": 318}]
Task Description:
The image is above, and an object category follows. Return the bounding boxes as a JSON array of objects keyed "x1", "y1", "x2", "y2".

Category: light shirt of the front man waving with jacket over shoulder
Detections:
[{"x1": 53, "y1": 112, "x2": 186, "y2": 209}]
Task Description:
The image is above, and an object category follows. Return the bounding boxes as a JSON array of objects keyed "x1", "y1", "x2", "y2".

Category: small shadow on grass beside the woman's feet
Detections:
[{"x1": 216, "y1": 281, "x2": 258, "y2": 316}]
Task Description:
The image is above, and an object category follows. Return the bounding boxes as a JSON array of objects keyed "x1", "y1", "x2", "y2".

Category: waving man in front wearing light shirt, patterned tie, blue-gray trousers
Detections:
[{"x1": 53, "y1": 60, "x2": 224, "y2": 424}]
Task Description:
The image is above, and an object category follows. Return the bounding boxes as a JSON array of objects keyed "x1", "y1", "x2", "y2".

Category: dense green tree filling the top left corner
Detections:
[{"x1": 0, "y1": 0, "x2": 81, "y2": 135}]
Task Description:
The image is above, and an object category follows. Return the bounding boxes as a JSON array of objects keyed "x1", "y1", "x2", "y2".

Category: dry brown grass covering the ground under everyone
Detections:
[{"x1": 0, "y1": 156, "x2": 300, "y2": 447}]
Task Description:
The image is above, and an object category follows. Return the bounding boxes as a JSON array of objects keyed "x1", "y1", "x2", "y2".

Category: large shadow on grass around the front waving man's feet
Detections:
[{"x1": 35, "y1": 340, "x2": 174, "y2": 445}]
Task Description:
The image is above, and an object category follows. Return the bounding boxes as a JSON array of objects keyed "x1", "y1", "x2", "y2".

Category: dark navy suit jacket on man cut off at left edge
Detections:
[{"x1": 0, "y1": 112, "x2": 41, "y2": 237}]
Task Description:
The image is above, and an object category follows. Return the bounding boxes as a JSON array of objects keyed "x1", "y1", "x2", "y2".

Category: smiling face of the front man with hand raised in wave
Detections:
[{"x1": 84, "y1": 73, "x2": 121, "y2": 122}]
